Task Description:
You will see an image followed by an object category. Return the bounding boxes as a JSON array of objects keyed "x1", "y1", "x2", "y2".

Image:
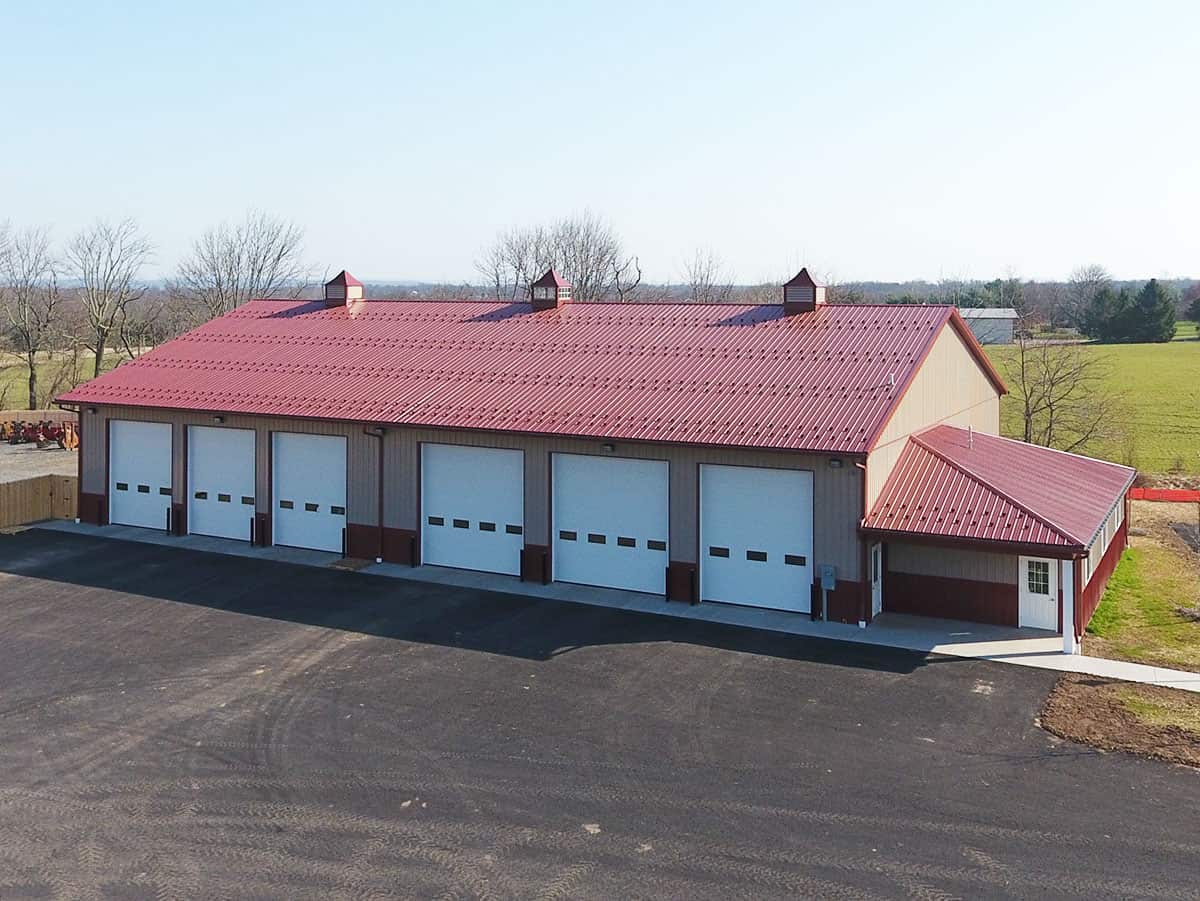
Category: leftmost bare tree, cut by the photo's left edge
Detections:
[{"x1": 0, "y1": 228, "x2": 60, "y2": 410}]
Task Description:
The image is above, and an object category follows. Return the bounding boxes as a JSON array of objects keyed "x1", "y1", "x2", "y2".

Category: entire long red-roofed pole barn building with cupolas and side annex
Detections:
[{"x1": 59, "y1": 271, "x2": 1133, "y2": 647}]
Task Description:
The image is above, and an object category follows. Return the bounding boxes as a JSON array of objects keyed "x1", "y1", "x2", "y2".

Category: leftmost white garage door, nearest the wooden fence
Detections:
[{"x1": 108, "y1": 419, "x2": 170, "y2": 530}]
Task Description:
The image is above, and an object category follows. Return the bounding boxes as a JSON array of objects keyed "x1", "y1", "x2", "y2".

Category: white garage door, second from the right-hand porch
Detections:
[{"x1": 551, "y1": 453, "x2": 668, "y2": 594}]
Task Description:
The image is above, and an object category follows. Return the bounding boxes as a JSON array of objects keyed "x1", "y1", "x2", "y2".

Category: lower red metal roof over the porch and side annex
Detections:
[{"x1": 863, "y1": 426, "x2": 1134, "y2": 549}]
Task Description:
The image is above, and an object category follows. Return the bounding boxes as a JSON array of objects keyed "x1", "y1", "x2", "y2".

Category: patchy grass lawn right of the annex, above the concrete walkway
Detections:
[{"x1": 1084, "y1": 501, "x2": 1200, "y2": 671}]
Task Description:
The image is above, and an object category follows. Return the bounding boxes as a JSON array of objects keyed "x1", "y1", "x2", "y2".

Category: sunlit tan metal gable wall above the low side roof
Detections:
[{"x1": 866, "y1": 325, "x2": 1000, "y2": 506}]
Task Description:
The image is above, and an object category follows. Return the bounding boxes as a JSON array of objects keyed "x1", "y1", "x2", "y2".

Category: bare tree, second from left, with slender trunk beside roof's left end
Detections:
[{"x1": 66, "y1": 220, "x2": 154, "y2": 376}]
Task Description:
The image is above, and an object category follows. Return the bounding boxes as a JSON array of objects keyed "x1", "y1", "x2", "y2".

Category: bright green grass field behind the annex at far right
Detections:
[{"x1": 988, "y1": 323, "x2": 1200, "y2": 475}]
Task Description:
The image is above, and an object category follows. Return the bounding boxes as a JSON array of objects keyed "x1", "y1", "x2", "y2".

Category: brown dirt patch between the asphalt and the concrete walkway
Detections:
[{"x1": 1042, "y1": 673, "x2": 1200, "y2": 768}]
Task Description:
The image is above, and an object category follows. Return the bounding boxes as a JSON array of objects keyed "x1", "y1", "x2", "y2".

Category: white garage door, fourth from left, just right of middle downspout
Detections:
[{"x1": 421, "y1": 444, "x2": 524, "y2": 576}]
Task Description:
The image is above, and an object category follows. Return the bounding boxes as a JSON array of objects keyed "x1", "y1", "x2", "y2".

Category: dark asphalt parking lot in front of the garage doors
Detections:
[{"x1": 0, "y1": 530, "x2": 1200, "y2": 901}]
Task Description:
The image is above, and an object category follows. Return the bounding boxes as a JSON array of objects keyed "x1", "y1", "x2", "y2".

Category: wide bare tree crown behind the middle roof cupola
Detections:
[{"x1": 475, "y1": 212, "x2": 642, "y2": 301}]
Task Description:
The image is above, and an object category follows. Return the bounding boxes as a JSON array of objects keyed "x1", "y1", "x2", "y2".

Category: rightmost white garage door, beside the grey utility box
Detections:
[{"x1": 700, "y1": 465, "x2": 812, "y2": 613}]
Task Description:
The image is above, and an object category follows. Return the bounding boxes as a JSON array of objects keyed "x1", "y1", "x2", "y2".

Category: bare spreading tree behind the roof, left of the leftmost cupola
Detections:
[{"x1": 170, "y1": 210, "x2": 313, "y2": 323}]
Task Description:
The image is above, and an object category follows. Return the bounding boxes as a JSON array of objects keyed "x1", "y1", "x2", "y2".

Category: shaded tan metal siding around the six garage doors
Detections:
[{"x1": 82, "y1": 407, "x2": 863, "y2": 581}]
